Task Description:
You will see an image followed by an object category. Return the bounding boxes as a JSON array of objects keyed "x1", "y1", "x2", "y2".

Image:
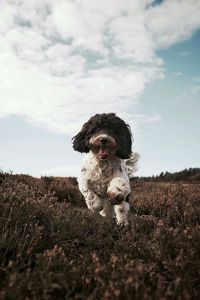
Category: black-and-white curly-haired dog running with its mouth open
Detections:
[{"x1": 72, "y1": 113, "x2": 138, "y2": 226}]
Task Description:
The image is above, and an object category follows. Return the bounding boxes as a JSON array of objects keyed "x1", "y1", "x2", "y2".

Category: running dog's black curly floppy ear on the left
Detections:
[{"x1": 72, "y1": 123, "x2": 89, "y2": 153}]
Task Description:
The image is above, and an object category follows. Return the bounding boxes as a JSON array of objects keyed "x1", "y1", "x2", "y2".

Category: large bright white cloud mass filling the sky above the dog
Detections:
[{"x1": 0, "y1": 0, "x2": 200, "y2": 134}]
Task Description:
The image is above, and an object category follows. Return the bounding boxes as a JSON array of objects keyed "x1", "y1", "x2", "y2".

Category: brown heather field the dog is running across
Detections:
[{"x1": 0, "y1": 172, "x2": 200, "y2": 300}]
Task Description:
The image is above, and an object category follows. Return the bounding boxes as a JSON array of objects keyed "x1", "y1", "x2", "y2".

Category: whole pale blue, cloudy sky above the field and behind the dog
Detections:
[{"x1": 0, "y1": 0, "x2": 200, "y2": 177}]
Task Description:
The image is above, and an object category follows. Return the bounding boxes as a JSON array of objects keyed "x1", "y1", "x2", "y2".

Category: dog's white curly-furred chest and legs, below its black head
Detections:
[{"x1": 78, "y1": 152, "x2": 134, "y2": 225}]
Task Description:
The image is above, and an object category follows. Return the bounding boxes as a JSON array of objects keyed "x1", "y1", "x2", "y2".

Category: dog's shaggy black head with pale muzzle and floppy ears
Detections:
[{"x1": 73, "y1": 113, "x2": 132, "y2": 159}]
